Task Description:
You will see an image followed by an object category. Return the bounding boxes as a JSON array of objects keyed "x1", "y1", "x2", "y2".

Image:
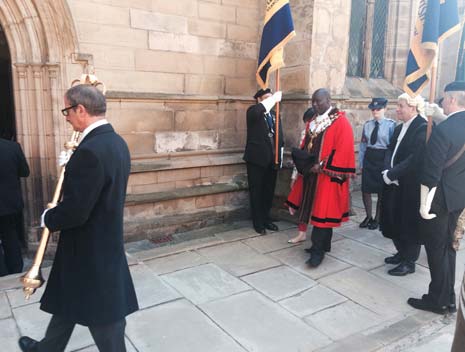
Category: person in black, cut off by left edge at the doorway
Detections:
[{"x1": 0, "y1": 138, "x2": 29, "y2": 276}]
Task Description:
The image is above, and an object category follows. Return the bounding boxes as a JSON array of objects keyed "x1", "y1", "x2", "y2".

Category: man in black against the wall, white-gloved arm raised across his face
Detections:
[{"x1": 243, "y1": 89, "x2": 284, "y2": 234}]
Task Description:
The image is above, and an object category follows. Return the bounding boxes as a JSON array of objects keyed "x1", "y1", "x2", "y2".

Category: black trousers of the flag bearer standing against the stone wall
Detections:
[{"x1": 247, "y1": 163, "x2": 278, "y2": 232}]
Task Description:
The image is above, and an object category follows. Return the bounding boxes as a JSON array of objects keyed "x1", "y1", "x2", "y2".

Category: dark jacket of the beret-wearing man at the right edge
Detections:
[{"x1": 421, "y1": 111, "x2": 465, "y2": 212}]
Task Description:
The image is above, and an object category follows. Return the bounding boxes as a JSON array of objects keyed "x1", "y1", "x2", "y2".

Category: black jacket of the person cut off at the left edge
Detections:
[{"x1": 0, "y1": 138, "x2": 29, "y2": 216}]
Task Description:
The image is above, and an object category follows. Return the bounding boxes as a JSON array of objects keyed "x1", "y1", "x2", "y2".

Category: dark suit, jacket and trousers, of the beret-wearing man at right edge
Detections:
[{"x1": 420, "y1": 111, "x2": 465, "y2": 306}]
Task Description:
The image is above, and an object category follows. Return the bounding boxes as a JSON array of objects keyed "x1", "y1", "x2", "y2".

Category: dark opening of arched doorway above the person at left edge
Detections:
[{"x1": 0, "y1": 26, "x2": 16, "y2": 140}]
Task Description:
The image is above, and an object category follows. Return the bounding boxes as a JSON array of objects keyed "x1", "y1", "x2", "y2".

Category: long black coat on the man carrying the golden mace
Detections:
[{"x1": 41, "y1": 124, "x2": 138, "y2": 326}]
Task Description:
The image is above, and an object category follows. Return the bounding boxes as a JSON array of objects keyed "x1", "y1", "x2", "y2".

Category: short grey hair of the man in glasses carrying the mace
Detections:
[{"x1": 65, "y1": 84, "x2": 107, "y2": 116}]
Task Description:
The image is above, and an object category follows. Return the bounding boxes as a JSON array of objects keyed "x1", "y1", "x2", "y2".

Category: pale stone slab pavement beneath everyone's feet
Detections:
[{"x1": 0, "y1": 194, "x2": 465, "y2": 352}]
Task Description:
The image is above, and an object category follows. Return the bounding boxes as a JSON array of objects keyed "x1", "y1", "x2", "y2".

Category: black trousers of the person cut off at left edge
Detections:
[{"x1": 0, "y1": 214, "x2": 23, "y2": 276}]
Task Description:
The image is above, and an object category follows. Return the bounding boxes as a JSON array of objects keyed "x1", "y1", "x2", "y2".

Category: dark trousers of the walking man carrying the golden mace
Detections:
[{"x1": 37, "y1": 315, "x2": 126, "y2": 352}]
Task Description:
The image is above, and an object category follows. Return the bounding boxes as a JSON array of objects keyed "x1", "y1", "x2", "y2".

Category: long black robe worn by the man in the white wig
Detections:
[{"x1": 381, "y1": 115, "x2": 427, "y2": 243}]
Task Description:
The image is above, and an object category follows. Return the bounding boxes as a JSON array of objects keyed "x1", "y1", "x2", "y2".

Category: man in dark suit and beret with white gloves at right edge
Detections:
[{"x1": 408, "y1": 82, "x2": 465, "y2": 314}]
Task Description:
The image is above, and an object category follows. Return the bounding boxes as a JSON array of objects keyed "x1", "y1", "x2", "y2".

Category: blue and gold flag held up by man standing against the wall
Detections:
[{"x1": 256, "y1": 0, "x2": 295, "y2": 88}]
